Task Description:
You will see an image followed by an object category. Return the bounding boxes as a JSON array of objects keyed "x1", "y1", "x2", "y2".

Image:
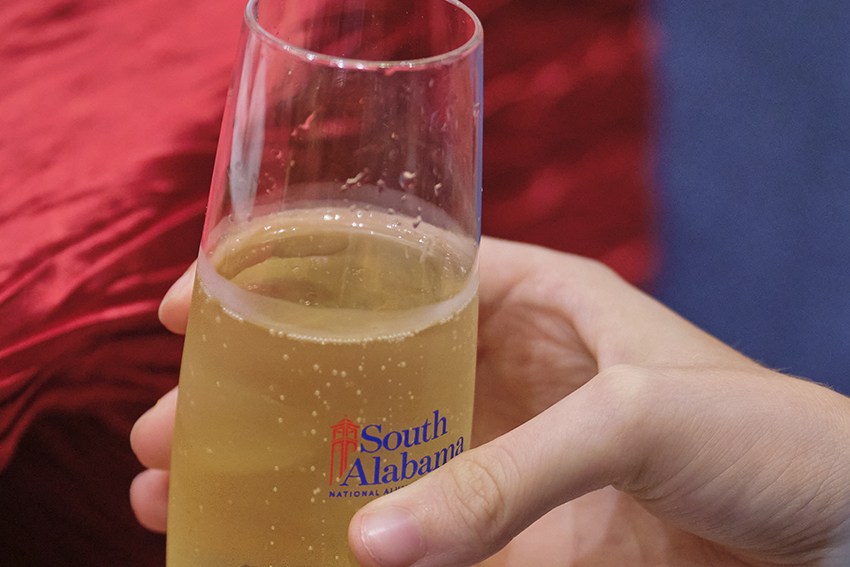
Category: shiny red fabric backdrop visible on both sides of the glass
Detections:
[{"x1": 0, "y1": 0, "x2": 652, "y2": 567}]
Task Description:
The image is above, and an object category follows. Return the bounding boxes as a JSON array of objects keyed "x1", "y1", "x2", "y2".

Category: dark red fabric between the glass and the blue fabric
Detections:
[{"x1": 466, "y1": 0, "x2": 655, "y2": 284}]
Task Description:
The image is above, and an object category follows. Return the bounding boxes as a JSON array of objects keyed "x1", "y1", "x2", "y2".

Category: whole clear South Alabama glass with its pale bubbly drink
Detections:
[{"x1": 168, "y1": 0, "x2": 482, "y2": 567}]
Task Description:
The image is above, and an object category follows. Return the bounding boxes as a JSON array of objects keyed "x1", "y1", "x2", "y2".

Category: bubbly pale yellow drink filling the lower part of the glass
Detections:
[{"x1": 167, "y1": 209, "x2": 477, "y2": 567}]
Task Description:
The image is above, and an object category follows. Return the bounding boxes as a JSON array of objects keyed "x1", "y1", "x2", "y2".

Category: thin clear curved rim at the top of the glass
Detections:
[{"x1": 244, "y1": 0, "x2": 484, "y2": 70}]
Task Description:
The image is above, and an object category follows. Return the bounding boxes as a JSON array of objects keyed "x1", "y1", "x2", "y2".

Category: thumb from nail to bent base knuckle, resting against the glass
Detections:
[{"x1": 348, "y1": 368, "x2": 640, "y2": 567}]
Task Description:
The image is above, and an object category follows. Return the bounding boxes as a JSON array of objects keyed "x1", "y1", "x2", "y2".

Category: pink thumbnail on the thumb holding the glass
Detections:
[{"x1": 360, "y1": 508, "x2": 425, "y2": 567}]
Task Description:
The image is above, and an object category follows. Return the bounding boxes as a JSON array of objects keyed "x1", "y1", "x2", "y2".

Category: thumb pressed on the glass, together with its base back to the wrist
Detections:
[{"x1": 349, "y1": 366, "x2": 850, "y2": 567}]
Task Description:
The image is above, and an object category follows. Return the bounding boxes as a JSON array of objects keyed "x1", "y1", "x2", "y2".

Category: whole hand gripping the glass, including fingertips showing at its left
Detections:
[{"x1": 131, "y1": 239, "x2": 850, "y2": 567}]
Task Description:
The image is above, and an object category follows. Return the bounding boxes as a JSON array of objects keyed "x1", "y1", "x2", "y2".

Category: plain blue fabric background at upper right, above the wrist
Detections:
[{"x1": 652, "y1": 0, "x2": 850, "y2": 393}]
